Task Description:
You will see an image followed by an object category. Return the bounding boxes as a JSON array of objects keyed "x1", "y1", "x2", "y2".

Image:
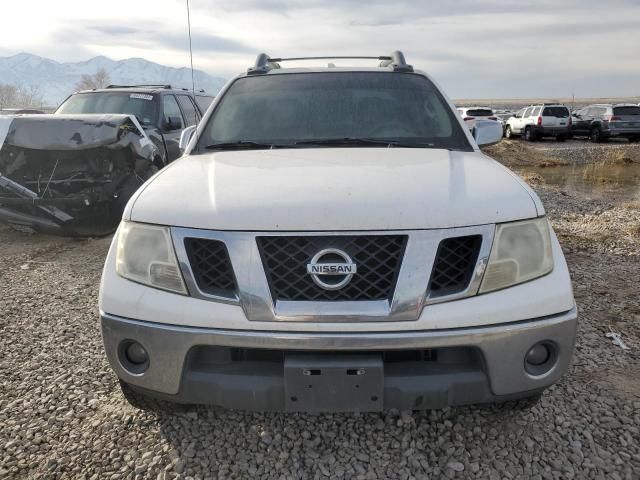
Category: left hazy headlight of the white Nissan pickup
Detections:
[{"x1": 116, "y1": 222, "x2": 187, "y2": 295}]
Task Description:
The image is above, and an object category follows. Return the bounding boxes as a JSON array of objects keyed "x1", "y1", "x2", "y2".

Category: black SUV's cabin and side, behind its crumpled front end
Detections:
[{"x1": 55, "y1": 85, "x2": 213, "y2": 168}]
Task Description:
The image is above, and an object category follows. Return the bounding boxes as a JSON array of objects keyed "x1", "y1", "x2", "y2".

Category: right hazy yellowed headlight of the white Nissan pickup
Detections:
[{"x1": 480, "y1": 217, "x2": 553, "y2": 293}]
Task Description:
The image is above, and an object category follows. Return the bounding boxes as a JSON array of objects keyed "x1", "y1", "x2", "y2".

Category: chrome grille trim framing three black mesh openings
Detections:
[{"x1": 171, "y1": 225, "x2": 495, "y2": 323}]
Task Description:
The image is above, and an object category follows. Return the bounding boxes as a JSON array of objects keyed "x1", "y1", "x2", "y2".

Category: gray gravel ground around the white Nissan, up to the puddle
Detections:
[{"x1": 0, "y1": 175, "x2": 640, "y2": 480}]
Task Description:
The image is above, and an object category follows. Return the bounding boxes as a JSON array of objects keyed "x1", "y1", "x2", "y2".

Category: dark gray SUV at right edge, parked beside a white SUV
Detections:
[{"x1": 573, "y1": 104, "x2": 640, "y2": 143}]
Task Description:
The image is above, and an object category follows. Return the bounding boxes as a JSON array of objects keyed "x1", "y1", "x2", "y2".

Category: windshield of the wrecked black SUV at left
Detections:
[{"x1": 56, "y1": 92, "x2": 156, "y2": 125}]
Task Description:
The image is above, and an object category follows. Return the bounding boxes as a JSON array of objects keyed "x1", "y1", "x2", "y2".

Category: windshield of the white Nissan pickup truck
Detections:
[{"x1": 198, "y1": 72, "x2": 472, "y2": 151}]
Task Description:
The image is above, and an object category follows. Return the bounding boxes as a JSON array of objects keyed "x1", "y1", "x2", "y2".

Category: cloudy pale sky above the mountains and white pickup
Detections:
[{"x1": 0, "y1": 0, "x2": 640, "y2": 98}]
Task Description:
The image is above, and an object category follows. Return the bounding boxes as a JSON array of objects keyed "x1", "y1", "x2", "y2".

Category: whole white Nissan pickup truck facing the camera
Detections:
[{"x1": 100, "y1": 52, "x2": 577, "y2": 412}]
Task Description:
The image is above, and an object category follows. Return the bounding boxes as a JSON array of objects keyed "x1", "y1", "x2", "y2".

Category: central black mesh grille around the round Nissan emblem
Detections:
[{"x1": 257, "y1": 235, "x2": 407, "y2": 301}]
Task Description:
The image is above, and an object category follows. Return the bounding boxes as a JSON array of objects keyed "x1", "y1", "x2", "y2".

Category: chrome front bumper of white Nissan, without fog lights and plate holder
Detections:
[{"x1": 101, "y1": 307, "x2": 577, "y2": 410}]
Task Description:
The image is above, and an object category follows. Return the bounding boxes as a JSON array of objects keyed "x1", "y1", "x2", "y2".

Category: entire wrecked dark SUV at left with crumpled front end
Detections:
[{"x1": 0, "y1": 85, "x2": 211, "y2": 236}]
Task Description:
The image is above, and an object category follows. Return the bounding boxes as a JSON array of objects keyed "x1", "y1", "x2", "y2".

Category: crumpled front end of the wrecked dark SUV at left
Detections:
[{"x1": 0, "y1": 114, "x2": 161, "y2": 236}]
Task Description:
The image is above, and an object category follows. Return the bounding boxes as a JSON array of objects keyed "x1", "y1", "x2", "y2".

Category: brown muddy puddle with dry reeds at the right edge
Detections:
[{"x1": 516, "y1": 163, "x2": 640, "y2": 202}]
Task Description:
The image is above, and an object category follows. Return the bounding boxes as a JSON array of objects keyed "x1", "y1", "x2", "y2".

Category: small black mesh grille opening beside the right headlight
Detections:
[{"x1": 429, "y1": 235, "x2": 482, "y2": 297}]
